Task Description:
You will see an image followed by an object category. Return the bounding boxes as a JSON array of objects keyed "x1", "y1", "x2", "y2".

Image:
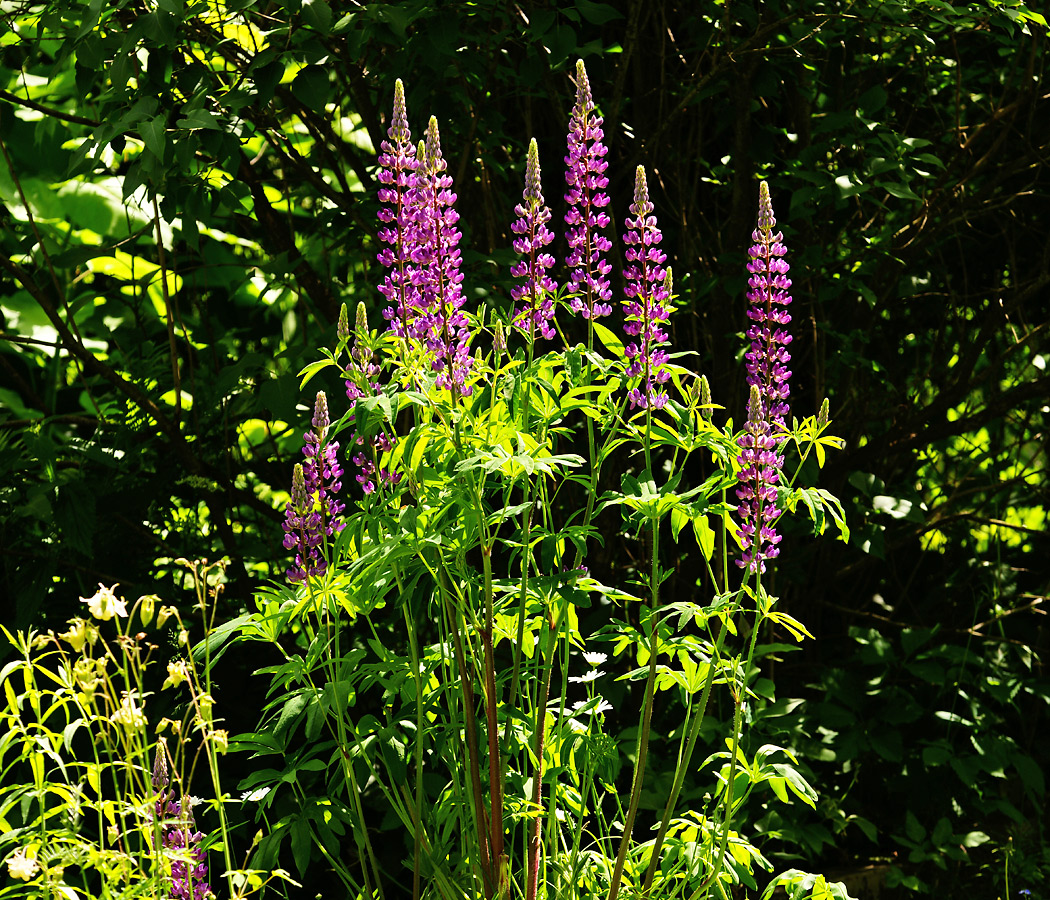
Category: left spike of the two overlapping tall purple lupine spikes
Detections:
[{"x1": 376, "y1": 79, "x2": 419, "y2": 337}]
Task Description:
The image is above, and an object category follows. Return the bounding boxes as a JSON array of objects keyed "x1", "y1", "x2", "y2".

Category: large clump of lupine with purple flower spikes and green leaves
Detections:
[{"x1": 236, "y1": 62, "x2": 846, "y2": 900}]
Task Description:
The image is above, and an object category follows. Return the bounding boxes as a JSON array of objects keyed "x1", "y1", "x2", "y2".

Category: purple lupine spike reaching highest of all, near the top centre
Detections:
[{"x1": 565, "y1": 60, "x2": 612, "y2": 319}]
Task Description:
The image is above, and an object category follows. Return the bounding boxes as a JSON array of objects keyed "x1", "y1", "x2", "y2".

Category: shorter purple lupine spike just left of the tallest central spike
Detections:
[{"x1": 510, "y1": 138, "x2": 558, "y2": 340}]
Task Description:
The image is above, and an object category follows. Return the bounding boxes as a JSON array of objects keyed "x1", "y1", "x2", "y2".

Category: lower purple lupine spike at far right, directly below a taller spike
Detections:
[{"x1": 736, "y1": 384, "x2": 783, "y2": 572}]
